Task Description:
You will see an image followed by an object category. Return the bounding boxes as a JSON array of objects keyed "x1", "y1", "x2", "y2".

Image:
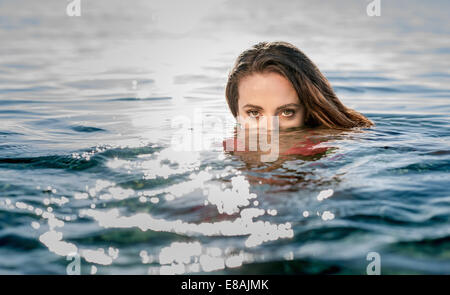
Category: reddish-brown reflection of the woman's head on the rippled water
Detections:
[{"x1": 224, "y1": 128, "x2": 344, "y2": 193}]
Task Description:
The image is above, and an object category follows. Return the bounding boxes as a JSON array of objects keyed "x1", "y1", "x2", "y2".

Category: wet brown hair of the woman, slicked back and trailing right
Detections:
[{"x1": 225, "y1": 41, "x2": 375, "y2": 129}]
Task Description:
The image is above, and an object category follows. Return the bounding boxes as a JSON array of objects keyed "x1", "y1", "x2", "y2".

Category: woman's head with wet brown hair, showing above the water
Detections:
[{"x1": 226, "y1": 42, "x2": 374, "y2": 129}]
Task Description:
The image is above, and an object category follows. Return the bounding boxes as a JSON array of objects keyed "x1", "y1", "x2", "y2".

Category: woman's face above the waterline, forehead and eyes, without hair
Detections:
[{"x1": 238, "y1": 72, "x2": 305, "y2": 129}]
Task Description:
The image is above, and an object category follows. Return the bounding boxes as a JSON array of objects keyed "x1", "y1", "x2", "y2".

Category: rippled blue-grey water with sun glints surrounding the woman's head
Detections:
[{"x1": 0, "y1": 0, "x2": 450, "y2": 274}]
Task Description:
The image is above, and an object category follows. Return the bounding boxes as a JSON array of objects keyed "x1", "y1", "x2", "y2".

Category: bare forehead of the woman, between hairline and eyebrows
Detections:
[{"x1": 238, "y1": 72, "x2": 298, "y2": 107}]
